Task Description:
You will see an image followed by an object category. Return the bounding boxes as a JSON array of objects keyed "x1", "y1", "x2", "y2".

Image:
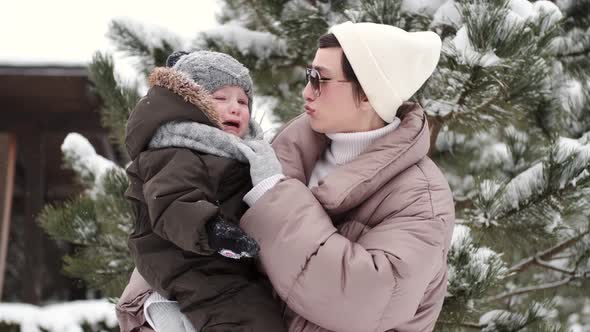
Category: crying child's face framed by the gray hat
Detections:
[{"x1": 212, "y1": 86, "x2": 250, "y2": 138}]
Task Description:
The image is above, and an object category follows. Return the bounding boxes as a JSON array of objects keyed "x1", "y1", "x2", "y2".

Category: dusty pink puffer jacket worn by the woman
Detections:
[{"x1": 241, "y1": 103, "x2": 455, "y2": 332}]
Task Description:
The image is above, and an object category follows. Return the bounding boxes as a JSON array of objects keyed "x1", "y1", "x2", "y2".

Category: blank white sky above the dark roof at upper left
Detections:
[{"x1": 0, "y1": 0, "x2": 219, "y2": 65}]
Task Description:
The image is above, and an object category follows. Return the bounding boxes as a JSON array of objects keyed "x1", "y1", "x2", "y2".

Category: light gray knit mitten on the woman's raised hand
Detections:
[{"x1": 238, "y1": 139, "x2": 283, "y2": 186}]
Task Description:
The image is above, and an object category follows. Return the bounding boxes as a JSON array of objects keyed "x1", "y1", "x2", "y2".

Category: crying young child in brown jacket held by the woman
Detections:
[{"x1": 117, "y1": 51, "x2": 286, "y2": 332}]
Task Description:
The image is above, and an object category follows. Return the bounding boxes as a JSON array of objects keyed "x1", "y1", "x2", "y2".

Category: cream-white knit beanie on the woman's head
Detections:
[{"x1": 330, "y1": 22, "x2": 442, "y2": 123}]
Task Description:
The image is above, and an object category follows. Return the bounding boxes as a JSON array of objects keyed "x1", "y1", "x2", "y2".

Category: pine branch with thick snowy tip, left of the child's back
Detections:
[{"x1": 39, "y1": 133, "x2": 133, "y2": 296}]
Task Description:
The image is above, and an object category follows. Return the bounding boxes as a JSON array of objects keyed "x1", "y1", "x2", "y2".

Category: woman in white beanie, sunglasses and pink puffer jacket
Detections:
[{"x1": 118, "y1": 22, "x2": 454, "y2": 332}]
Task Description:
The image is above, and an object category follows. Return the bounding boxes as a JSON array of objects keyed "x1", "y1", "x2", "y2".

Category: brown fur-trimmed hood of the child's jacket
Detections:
[{"x1": 125, "y1": 68, "x2": 261, "y2": 160}]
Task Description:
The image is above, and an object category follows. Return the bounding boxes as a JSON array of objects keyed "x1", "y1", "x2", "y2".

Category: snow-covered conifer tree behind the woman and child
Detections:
[{"x1": 41, "y1": 0, "x2": 590, "y2": 331}]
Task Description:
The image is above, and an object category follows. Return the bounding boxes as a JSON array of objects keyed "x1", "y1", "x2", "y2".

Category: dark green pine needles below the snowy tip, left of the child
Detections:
[{"x1": 39, "y1": 169, "x2": 133, "y2": 297}]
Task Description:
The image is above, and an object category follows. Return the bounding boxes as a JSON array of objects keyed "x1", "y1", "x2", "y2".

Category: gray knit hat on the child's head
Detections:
[{"x1": 166, "y1": 51, "x2": 252, "y2": 113}]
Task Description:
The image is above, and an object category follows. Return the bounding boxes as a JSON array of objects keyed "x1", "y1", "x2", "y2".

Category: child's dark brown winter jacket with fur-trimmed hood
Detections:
[{"x1": 117, "y1": 68, "x2": 282, "y2": 331}]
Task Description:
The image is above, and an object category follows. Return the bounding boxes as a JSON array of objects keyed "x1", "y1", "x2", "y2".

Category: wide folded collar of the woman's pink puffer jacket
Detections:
[{"x1": 273, "y1": 102, "x2": 430, "y2": 215}]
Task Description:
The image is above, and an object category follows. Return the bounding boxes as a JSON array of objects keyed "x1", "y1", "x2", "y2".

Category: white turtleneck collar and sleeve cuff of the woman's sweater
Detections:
[{"x1": 244, "y1": 117, "x2": 400, "y2": 206}]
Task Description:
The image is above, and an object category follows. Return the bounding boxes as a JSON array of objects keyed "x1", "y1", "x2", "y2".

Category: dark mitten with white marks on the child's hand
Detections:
[{"x1": 206, "y1": 216, "x2": 259, "y2": 259}]
